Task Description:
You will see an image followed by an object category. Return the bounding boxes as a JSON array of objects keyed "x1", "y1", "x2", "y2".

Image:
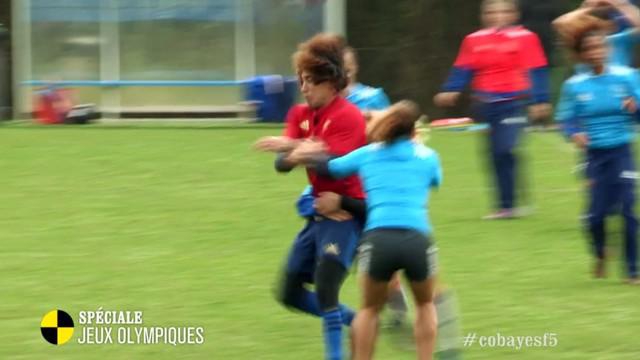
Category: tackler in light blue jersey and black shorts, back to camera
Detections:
[{"x1": 291, "y1": 101, "x2": 442, "y2": 360}]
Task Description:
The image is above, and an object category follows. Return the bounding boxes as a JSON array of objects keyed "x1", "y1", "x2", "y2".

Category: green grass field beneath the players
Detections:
[{"x1": 0, "y1": 122, "x2": 640, "y2": 360}]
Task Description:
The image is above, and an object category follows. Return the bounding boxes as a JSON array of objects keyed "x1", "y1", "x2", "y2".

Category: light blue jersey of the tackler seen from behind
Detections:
[{"x1": 328, "y1": 138, "x2": 442, "y2": 234}]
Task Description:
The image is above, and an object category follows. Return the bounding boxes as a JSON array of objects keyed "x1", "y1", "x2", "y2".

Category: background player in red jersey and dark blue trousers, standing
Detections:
[{"x1": 434, "y1": 0, "x2": 550, "y2": 219}]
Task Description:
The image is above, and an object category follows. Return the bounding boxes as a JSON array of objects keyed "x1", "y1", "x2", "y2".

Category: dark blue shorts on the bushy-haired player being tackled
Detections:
[{"x1": 287, "y1": 217, "x2": 362, "y2": 283}]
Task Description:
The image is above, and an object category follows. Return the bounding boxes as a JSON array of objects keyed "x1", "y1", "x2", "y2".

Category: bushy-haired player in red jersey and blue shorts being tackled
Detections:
[{"x1": 256, "y1": 34, "x2": 366, "y2": 360}]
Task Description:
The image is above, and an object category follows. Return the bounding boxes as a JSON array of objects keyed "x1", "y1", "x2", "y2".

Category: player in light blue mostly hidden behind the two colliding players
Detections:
[{"x1": 297, "y1": 46, "x2": 408, "y2": 327}]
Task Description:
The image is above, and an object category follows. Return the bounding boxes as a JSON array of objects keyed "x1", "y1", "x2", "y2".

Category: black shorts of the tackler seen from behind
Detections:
[{"x1": 358, "y1": 228, "x2": 437, "y2": 282}]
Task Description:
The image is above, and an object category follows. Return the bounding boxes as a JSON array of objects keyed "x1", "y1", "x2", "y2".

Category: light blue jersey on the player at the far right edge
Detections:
[{"x1": 556, "y1": 66, "x2": 640, "y2": 149}]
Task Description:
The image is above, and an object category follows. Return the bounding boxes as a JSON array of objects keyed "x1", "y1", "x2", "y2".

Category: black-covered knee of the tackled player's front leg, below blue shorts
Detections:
[{"x1": 315, "y1": 257, "x2": 347, "y2": 311}]
